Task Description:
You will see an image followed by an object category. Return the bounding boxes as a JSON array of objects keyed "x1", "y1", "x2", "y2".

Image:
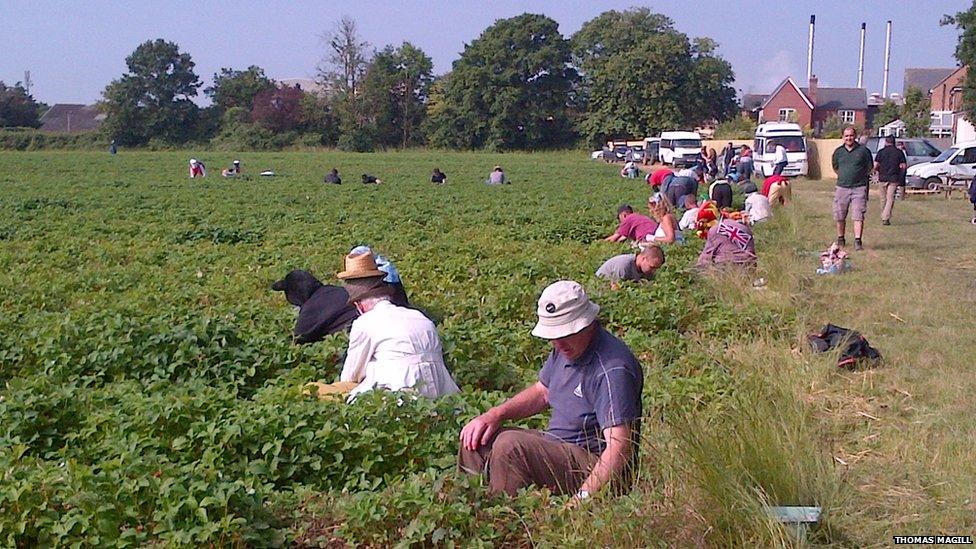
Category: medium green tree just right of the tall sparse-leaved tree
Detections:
[{"x1": 364, "y1": 42, "x2": 434, "y2": 147}]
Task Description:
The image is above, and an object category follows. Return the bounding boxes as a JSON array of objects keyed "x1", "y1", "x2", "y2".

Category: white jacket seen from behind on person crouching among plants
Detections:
[{"x1": 339, "y1": 301, "x2": 460, "y2": 400}]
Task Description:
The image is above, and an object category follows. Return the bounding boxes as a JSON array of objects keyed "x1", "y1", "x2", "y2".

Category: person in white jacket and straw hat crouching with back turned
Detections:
[{"x1": 320, "y1": 253, "x2": 460, "y2": 400}]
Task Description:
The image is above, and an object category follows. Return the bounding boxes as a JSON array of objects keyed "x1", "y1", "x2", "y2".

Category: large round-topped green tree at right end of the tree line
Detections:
[{"x1": 572, "y1": 8, "x2": 737, "y2": 143}]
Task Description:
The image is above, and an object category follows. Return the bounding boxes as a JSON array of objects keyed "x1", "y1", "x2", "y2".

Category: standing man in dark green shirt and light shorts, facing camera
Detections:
[{"x1": 831, "y1": 126, "x2": 874, "y2": 250}]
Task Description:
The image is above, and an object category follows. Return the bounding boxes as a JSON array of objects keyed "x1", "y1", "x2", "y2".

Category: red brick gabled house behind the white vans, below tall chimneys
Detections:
[{"x1": 759, "y1": 76, "x2": 868, "y2": 131}]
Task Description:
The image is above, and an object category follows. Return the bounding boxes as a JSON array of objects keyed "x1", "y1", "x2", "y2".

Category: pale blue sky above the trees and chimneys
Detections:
[{"x1": 0, "y1": 0, "x2": 970, "y2": 104}]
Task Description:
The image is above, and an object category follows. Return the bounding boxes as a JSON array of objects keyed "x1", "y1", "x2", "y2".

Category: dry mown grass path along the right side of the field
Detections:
[{"x1": 761, "y1": 182, "x2": 976, "y2": 546}]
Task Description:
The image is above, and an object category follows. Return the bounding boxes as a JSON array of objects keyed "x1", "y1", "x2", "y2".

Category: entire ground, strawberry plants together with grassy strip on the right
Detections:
[{"x1": 0, "y1": 151, "x2": 976, "y2": 547}]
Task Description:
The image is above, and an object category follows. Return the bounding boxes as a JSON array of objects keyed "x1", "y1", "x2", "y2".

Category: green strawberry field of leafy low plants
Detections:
[{"x1": 0, "y1": 151, "x2": 816, "y2": 547}]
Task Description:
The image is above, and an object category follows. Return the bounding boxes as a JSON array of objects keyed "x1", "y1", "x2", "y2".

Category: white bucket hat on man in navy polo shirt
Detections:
[{"x1": 532, "y1": 280, "x2": 600, "y2": 339}]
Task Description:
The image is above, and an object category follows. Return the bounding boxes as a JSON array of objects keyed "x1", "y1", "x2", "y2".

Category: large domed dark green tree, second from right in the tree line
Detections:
[{"x1": 428, "y1": 14, "x2": 576, "y2": 150}]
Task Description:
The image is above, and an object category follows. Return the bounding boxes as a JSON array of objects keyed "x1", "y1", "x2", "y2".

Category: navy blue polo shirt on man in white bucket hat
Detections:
[{"x1": 539, "y1": 326, "x2": 644, "y2": 454}]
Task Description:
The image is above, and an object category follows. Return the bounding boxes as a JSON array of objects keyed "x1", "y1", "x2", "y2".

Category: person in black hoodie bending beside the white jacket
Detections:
[{"x1": 271, "y1": 270, "x2": 359, "y2": 344}]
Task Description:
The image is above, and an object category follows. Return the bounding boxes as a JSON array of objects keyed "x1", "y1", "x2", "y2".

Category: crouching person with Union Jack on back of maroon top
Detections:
[{"x1": 697, "y1": 200, "x2": 756, "y2": 270}]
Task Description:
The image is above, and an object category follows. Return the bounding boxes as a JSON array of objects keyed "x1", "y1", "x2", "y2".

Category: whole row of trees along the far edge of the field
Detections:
[{"x1": 1, "y1": 8, "x2": 737, "y2": 151}]
